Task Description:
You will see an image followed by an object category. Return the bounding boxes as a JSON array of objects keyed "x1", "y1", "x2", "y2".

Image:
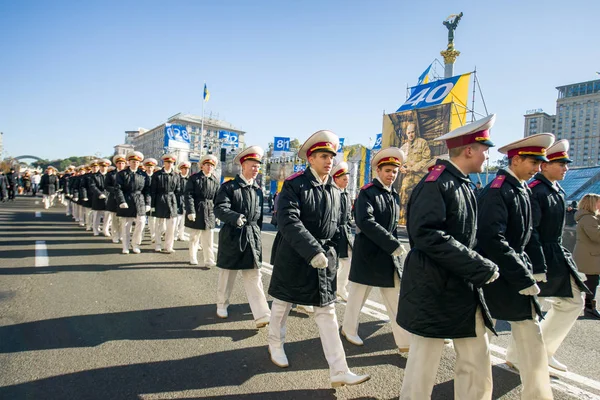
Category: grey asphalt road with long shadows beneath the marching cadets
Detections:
[{"x1": 0, "y1": 197, "x2": 600, "y2": 400}]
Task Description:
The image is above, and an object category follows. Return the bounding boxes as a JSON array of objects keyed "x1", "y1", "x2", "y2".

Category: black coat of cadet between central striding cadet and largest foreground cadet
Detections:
[{"x1": 348, "y1": 179, "x2": 401, "y2": 287}]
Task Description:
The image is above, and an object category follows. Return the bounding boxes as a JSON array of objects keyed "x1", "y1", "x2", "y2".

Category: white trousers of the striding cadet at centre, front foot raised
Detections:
[{"x1": 268, "y1": 299, "x2": 349, "y2": 376}]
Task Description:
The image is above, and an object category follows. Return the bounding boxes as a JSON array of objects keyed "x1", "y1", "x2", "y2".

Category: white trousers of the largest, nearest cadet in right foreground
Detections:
[{"x1": 400, "y1": 308, "x2": 492, "y2": 400}]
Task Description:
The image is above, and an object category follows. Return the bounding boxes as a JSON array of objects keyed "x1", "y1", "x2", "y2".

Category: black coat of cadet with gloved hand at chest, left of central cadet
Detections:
[{"x1": 216, "y1": 175, "x2": 263, "y2": 270}]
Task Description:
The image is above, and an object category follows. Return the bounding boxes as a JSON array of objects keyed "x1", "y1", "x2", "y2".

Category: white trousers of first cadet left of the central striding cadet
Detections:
[{"x1": 217, "y1": 268, "x2": 271, "y2": 321}]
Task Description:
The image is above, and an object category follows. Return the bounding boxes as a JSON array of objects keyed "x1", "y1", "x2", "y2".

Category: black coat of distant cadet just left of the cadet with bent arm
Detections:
[{"x1": 184, "y1": 171, "x2": 219, "y2": 230}]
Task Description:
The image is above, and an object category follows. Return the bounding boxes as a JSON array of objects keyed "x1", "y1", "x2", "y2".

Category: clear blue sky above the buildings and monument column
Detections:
[{"x1": 0, "y1": 0, "x2": 600, "y2": 159}]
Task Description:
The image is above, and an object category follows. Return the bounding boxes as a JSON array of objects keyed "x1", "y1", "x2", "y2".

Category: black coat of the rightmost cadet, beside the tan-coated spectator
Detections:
[{"x1": 525, "y1": 173, "x2": 587, "y2": 297}]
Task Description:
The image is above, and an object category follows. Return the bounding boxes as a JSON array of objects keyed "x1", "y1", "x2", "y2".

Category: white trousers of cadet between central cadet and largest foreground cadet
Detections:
[{"x1": 342, "y1": 273, "x2": 411, "y2": 348}]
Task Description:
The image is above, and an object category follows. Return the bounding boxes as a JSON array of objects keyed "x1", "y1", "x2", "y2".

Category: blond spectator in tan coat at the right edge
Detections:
[{"x1": 573, "y1": 193, "x2": 600, "y2": 319}]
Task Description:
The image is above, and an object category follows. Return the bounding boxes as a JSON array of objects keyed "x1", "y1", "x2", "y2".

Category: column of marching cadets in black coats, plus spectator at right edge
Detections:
[{"x1": 4, "y1": 119, "x2": 600, "y2": 399}]
